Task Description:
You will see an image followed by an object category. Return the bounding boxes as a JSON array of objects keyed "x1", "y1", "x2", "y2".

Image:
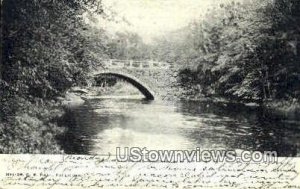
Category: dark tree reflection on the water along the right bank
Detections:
[{"x1": 180, "y1": 102, "x2": 300, "y2": 156}]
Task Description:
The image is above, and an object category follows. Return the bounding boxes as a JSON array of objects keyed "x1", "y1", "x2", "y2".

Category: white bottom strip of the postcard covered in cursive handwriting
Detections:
[{"x1": 0, "y1": 155, "x2": 300, "y2": 189}]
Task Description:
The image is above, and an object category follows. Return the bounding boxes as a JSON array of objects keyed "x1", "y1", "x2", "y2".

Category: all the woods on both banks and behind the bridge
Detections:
[{"x1": 0, "y1": 0, "x2": 300, "y2": 153}]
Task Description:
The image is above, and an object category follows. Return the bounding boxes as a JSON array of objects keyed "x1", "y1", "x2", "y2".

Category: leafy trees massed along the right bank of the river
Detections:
[{"x1": 156, "y1": 0, "x2": 300, "y2": 102}]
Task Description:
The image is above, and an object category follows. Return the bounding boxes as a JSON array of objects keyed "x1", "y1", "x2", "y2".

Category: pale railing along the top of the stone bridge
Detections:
[{"x1": 101, "y1": 59, "x2": 170, "y2": 69}]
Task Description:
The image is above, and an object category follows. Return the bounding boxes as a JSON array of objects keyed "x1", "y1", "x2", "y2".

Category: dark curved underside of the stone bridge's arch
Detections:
[{"x1": 94, "y1": 72, "x2": 154, "y2": 100}]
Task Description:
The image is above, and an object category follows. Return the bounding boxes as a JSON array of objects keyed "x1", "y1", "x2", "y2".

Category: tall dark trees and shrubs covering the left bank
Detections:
[{"x1": 0, "y1": 0, "x2": 103, "y2": 153}]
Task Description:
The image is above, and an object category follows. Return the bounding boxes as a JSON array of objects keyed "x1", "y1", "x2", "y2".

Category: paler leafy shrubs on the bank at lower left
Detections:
[{"x1": 0, "y1": 98, "x2": 65, "y2": 154}]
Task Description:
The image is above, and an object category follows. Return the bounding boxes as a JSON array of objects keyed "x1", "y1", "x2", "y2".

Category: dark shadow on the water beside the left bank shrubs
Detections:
[{"x1": 58, "y1": 97, "x2": 153, "y2": 154}]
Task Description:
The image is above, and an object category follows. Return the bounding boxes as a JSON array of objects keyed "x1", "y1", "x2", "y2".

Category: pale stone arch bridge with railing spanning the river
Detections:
[{"x1": 90, "y1": 59, "x2": 178, "y2": 100}]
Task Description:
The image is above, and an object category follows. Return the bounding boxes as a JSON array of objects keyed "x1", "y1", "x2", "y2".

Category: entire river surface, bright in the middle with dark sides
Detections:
[{"x1": 61, "y1": 97, "x2": 300, "y2": 157}]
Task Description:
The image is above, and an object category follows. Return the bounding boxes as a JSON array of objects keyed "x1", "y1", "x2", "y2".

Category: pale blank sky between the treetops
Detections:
[{"x1": 85, "y1": 0, "x2": 220, "y2": 43}]
